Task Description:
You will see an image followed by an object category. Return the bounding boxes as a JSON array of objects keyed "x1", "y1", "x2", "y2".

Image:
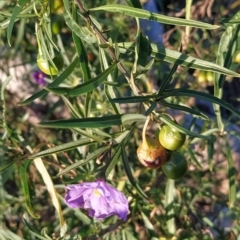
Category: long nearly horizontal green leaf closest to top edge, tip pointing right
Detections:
[{"x1": 89, "y1": 4, "x2": 219, "y2": 29}]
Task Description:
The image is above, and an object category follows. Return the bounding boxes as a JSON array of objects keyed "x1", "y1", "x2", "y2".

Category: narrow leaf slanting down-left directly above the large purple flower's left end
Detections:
[{"x1": 57, "y1": 145, "x2": 111, "y2": 176}]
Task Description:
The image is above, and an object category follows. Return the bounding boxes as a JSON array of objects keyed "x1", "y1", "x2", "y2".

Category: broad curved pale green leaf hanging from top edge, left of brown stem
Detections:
[{"x1": 63, "y1": 0, "x2": 97, "y2": 43}]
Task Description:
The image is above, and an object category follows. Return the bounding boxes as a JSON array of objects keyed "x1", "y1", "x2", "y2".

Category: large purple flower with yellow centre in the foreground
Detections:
[{"x1": 65, "y1": 180, "x2": 129, "y2": 221}]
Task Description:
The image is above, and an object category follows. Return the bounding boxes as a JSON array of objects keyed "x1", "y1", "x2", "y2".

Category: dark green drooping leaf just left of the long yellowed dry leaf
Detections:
[{"x1": 20, "y1": 159, "x2": 40, "y2": 218}]
